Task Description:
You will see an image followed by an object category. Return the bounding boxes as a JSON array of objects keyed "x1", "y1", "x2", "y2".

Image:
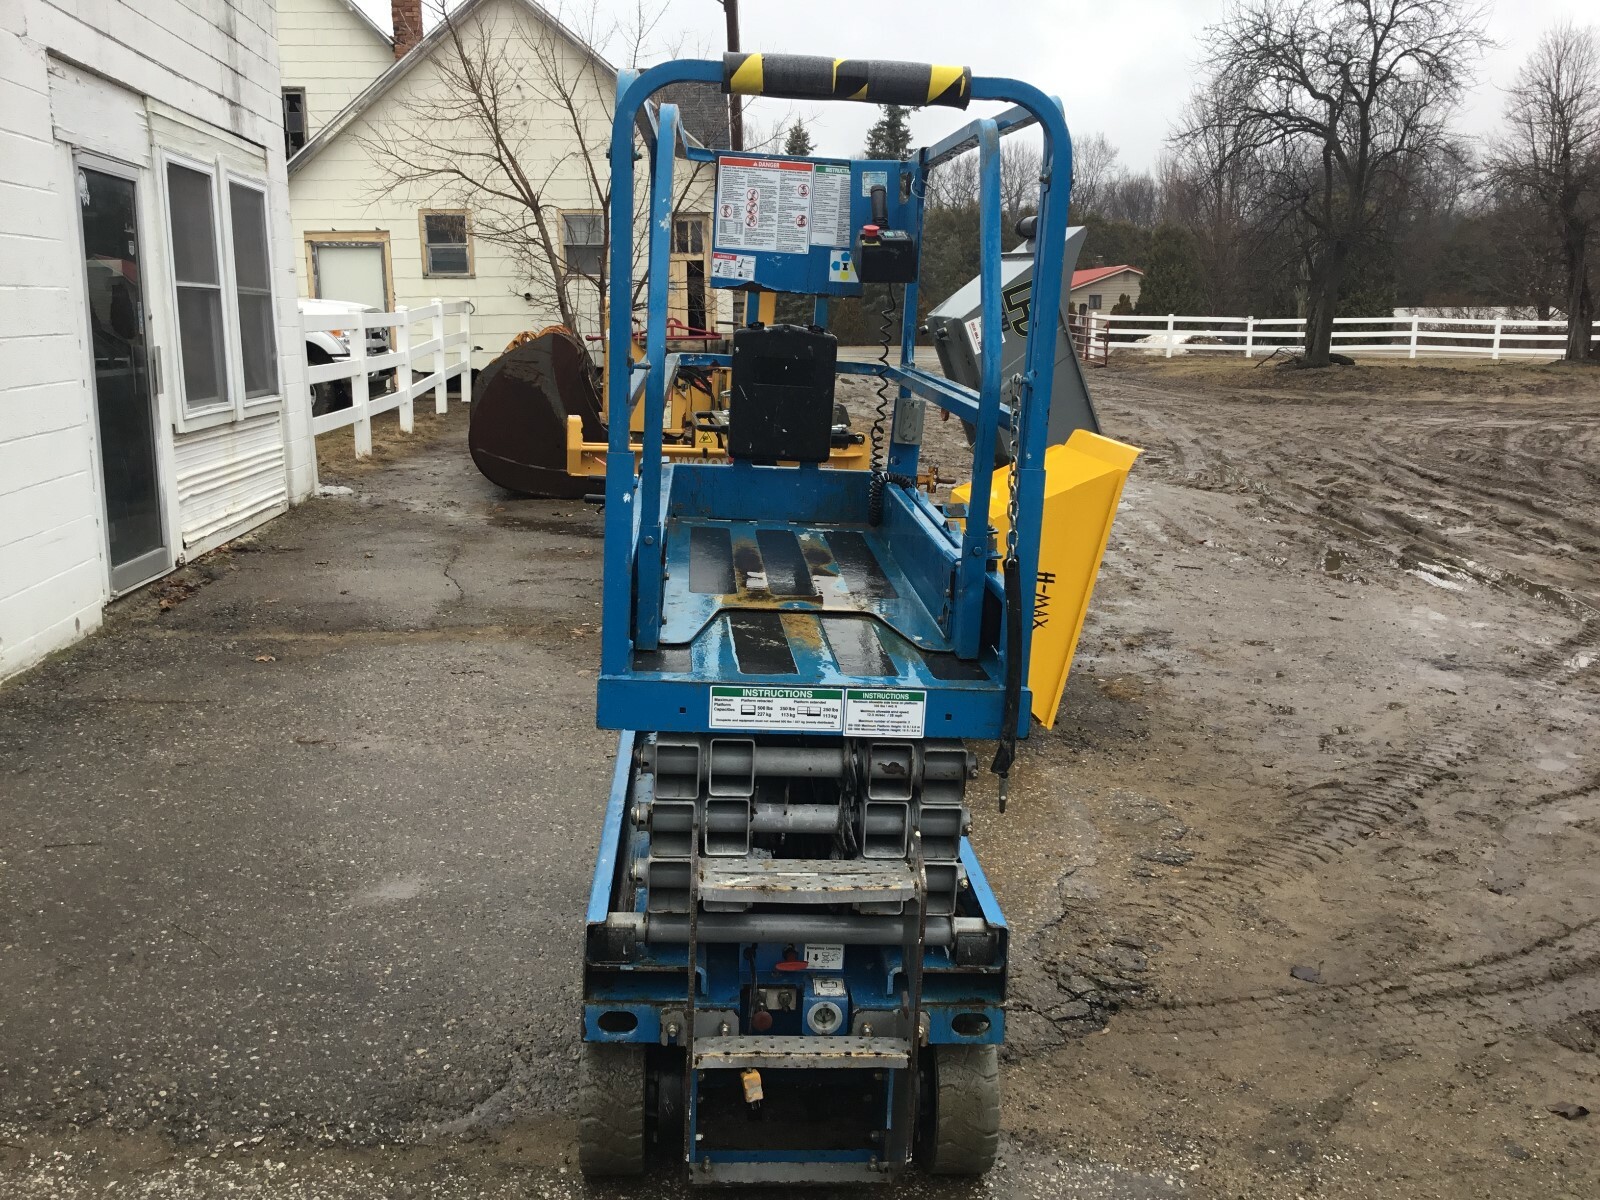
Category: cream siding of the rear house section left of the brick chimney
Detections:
[{"x1": 278, "y1": 0, "x2": 393, "y2": 144}]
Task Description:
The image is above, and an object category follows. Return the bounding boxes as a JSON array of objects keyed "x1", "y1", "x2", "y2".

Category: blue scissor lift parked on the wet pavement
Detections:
[{"x1": 579, "y1": 54, "x2": 1070, "y2": 1182}]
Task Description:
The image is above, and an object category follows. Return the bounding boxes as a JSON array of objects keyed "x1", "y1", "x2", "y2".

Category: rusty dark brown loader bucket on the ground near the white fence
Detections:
[{"x1": 467, "y1": 326, "x2": 606, "y2": 499}]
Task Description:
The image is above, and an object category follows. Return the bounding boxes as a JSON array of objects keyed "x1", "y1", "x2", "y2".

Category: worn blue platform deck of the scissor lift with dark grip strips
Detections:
[{"x1": 600, "y1": 464, "x2": 1026, "y2": 738}]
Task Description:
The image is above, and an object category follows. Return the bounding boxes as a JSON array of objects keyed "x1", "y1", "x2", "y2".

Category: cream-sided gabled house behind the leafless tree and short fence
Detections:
[{"x1": 280, "y1": 0, "x2": 731, "y2": 368}]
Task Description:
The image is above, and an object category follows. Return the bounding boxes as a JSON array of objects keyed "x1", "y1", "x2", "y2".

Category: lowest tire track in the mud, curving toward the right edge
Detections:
[{"x1": 1118, "y1": 917, "x2": 1600, "y2": 1042}]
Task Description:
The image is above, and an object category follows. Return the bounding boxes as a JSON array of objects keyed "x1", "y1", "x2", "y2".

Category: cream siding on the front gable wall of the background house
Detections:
[{"x1": 290, "y1": 0, "x2": 731, "y2": 368}]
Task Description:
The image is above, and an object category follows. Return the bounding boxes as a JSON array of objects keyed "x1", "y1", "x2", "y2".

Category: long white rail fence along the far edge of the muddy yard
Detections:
[{"x1": 1088, "y1": 314, "x2": 1600, "y2": 360}]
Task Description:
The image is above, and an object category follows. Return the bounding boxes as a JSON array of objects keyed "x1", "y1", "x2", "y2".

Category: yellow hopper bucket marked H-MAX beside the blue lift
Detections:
[{"x1": 950, "y1": 429, "x2": 1142, "y2": 728}]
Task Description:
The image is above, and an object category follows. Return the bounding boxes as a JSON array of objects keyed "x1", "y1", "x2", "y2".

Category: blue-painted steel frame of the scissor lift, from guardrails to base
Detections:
[{"x1": 584, "y1": 61, "x2": 1072, "y2": 1182}]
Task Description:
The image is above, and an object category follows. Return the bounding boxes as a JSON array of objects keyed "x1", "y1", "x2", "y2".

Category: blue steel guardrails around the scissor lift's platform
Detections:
[{"x1": 598, "y1": 59, "x2": 1072, "y2": 738}]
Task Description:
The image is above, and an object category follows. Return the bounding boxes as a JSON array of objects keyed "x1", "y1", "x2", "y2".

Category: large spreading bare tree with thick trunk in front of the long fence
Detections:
[{"x1": 1178, "y1": 0, "x2": 1486, "y2": 366}]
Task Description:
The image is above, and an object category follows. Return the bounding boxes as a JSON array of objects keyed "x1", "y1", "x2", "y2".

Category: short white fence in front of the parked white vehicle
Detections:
[{"x1": 301, "y1": 299, "x2": 472, "y2": 458}]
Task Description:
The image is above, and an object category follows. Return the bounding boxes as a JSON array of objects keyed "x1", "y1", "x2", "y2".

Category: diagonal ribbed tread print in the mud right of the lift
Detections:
[{"x1": 1146, "y1": 733, "x2": 1477, "y2": 923}]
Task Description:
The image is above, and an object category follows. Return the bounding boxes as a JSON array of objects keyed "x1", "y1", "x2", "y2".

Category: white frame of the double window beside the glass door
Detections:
[{"x1": 155, "y1": 147, "x2": 283, "y2": 434}]
